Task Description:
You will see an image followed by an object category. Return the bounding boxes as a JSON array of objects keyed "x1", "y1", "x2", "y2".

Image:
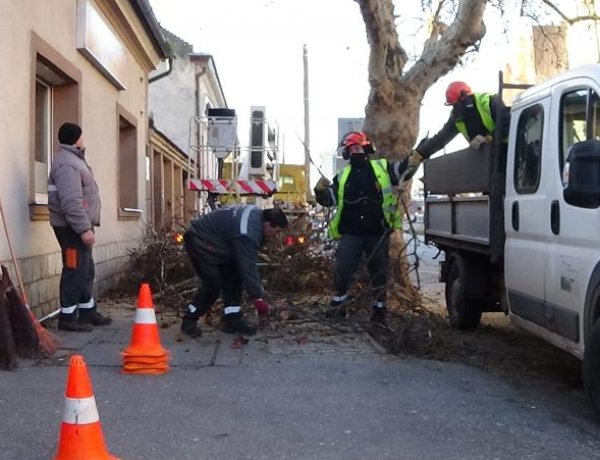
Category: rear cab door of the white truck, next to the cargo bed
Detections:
[{"x1": 504, "y1": 101, "x2": 551, "y2": 325}]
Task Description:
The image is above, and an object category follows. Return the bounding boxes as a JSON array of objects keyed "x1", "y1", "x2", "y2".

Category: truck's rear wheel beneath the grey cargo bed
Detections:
[{"x1": 446, "y1": 255, "x2": 481, "y2": 331}]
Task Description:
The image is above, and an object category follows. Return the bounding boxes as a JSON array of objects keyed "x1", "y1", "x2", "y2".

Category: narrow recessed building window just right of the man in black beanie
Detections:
[{"x1": 118, "y1": 114, "x2": 140, "y2": 218}]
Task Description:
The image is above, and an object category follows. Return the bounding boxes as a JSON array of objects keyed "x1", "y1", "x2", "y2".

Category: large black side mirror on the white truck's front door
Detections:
[{"x1": 564, "y1": 140, "x2": 600, "y2": 208}]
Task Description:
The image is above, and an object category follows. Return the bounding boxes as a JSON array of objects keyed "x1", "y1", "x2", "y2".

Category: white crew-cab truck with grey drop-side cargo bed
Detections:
[{"x1": 424, "y1": 65, "x2": 600, "y2": 409}]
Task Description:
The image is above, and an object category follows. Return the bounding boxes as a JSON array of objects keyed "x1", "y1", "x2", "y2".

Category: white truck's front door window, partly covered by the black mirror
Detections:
[{"x1": 558, "y1": 88, "x2": 600, "y2": 185}]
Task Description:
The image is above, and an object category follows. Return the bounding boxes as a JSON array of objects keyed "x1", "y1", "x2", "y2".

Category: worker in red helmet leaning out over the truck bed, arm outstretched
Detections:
[{"x1": 409, "y1": 81, "x2": 509, "y2": 174}]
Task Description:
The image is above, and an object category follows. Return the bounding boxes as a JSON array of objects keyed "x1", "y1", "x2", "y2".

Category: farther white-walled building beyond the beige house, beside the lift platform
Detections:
[{"x1": 149, "y1": 29, "x2": 227, "y2": 226}]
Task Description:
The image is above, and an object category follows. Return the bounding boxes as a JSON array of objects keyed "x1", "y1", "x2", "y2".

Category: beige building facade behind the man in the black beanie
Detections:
[{"x1": 0, "y1": 0, "x2": 166, "y2": 316}]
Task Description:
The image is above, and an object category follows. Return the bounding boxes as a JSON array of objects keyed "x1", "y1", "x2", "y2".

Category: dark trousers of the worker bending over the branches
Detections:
[{"x1": 184, "y1": 234, "x2": 242, "y2": 317}]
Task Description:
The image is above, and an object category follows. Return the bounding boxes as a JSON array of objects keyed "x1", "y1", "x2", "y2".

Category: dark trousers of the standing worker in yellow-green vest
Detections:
[{"x1": 334, "y1": 233, "x2": 390, "y2": 302}]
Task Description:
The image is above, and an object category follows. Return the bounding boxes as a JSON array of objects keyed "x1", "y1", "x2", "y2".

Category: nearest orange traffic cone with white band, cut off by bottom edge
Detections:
[{"x1": 54, "y1": 355, "x2": 118, "y2": 460}]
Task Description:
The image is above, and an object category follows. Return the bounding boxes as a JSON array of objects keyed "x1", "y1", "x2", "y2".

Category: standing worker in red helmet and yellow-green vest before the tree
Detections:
[{"x1": 314, "y1": 132, "x2": 408, "y2": 324}]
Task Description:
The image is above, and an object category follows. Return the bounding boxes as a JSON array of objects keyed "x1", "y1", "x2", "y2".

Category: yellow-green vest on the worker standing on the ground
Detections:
[{"x1": 328, "y1": 158, "x2": 402, "y2": 239}]
